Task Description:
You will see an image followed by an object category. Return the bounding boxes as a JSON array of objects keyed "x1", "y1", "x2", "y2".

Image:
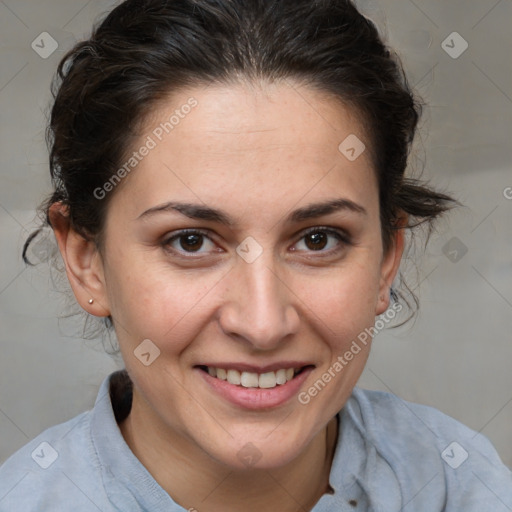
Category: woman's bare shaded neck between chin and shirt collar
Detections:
[{"x1": 119, "y1": 388, "x2": 338, "y2": 512}]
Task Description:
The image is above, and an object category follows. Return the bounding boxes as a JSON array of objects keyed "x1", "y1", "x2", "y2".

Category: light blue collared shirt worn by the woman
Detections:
[{"x1": 0, "y1": 376, "x2": 512, "y2": 512}]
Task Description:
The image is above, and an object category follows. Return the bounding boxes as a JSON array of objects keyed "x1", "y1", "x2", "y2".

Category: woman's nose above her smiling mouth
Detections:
[{"x1": 219, "y1": 255, "x2": 300, "y2": 350}]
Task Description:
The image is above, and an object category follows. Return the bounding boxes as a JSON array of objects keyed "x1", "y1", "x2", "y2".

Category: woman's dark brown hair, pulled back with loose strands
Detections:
[{"x1": 24, "y1": 0, "x2": 456, "y2": 330}]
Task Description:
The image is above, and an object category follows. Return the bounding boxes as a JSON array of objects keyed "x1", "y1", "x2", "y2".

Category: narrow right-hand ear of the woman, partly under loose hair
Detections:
[{"x1": 375, "y1": 214, "x2": 407, "y2": 315}]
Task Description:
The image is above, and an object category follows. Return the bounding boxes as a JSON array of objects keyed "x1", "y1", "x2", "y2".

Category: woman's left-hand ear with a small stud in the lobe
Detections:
[{"x1": 48, "y1": 202, "x2": 110, "y2": 316}]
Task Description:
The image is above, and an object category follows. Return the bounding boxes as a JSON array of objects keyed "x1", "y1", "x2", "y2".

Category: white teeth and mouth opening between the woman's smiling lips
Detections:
[{"x1": 198, "y1": 365, "x2": 312, "y2": 389}]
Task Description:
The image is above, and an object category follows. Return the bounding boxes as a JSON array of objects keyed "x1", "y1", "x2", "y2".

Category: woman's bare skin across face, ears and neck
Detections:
[{"x1": 51, "y1": 83, "x2": 403, "y2": 512}]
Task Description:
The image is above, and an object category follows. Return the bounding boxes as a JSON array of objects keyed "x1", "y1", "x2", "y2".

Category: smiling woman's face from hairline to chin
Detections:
[{"x1": 93, "y1": 84, "x2": 400, "y2": 468}]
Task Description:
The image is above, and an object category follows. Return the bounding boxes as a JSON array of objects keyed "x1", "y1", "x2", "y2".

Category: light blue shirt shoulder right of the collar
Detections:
[{"x1": 343, "y1": 387, "x2": 512, "y2": 511}]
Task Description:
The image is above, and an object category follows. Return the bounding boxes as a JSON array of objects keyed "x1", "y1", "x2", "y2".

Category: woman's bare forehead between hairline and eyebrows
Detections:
[{"x1": 110, "y1": 82, "x2": 377, "y2": 222}]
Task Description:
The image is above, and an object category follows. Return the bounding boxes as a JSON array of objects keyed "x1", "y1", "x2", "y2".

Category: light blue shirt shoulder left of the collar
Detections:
[{"x1": 0, "y1": 392, "x2": 114, "y2": 512}]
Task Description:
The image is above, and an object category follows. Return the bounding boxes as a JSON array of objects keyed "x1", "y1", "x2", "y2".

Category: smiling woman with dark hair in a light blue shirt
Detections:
[{"x1": 0, "y1": 0, "x2": 512, "y2": 512}]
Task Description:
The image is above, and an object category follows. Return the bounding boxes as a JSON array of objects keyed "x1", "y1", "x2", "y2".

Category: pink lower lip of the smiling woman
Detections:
[{"x1": 195, "y1": 368, "x2": 313, "y2": 410}]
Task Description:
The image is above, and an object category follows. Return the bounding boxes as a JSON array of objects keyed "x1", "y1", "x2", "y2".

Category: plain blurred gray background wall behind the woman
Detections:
[{"x1": 0, "y1": 0, "x2": 512, "y2": 467}]
